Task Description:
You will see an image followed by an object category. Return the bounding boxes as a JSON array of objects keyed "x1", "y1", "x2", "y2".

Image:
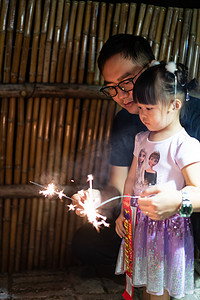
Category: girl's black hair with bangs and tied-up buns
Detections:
[{"x1": 133, "y1": 62, "x2": 197, "y2": 105}]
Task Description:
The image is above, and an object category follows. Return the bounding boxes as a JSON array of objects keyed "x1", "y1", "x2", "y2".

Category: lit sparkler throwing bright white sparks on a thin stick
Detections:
[{"x1": 30, "y1": 174, "x2": 138, "y2": 230}]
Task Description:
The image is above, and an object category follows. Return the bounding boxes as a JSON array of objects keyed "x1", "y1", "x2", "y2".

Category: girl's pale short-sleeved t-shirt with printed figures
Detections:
[{"x1": 134, "y1": 128, "x2": 200, "y2": 195}]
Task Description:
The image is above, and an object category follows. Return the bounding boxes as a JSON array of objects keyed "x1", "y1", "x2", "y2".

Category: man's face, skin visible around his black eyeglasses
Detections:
[{"x1": 102, "y1": 54, "x2": 145, "y2": 114}]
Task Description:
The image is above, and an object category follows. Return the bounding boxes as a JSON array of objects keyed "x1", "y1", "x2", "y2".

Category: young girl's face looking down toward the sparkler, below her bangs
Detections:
[{"x1": 138, "y1": 103, "x2": 172, "y2": 131}]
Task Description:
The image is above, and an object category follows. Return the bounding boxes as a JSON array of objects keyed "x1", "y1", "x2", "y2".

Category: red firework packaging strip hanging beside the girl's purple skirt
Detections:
[{"x1": 123, "y1": 196, "x2": 136, "y2": 300}]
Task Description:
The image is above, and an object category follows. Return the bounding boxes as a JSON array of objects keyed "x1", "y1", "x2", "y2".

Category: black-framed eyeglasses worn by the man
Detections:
[{"x1": 100, "y1": 64, "x2": 148, "y2": 97}]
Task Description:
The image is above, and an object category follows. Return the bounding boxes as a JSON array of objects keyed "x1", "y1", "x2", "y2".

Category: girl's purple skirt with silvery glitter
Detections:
[{"x1": 116, "y1": 209, "x2": 194, "y2": 298}]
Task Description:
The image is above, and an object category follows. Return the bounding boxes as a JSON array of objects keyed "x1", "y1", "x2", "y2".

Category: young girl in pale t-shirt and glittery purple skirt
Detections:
[{"x1": 120, "y1": 63, "x2": 200, "y2": 299}]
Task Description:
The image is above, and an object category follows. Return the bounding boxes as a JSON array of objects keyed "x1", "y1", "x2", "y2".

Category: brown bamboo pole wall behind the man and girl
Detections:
[{"x1": 0, "y1": 0, "x2": 200, "y2": 272}]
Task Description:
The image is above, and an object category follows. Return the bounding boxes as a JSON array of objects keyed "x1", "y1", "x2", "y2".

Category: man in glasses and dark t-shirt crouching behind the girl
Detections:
[{"x1": 72, "y1": 34, "x2": 200, "y2": 266}]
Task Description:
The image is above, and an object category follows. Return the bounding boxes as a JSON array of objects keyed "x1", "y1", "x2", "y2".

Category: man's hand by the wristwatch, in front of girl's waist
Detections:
[{"x1": 138, "y1": 186, "x2": 182, "y2": 220}]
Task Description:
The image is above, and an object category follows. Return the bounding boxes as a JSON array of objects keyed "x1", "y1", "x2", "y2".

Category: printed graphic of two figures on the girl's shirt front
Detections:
[{"x1": 136, "y1": 149, "x2": 160, "y2": 187}]
